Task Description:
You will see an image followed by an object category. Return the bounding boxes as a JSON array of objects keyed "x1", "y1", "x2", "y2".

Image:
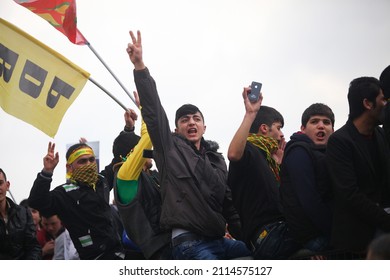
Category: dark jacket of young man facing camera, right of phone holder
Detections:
[{"x1": 280, "y1": 133, "x2": 332, "y2": 244}]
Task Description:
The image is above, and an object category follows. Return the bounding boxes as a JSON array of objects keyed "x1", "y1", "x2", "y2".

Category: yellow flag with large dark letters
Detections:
[{"x1": 0, "y1": 18, "x2": 89, "y2": 137}]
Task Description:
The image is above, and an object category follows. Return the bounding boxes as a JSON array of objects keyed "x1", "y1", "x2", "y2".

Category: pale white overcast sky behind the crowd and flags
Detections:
[{"x1": 0, "y1": 0, "x2": 390, "y2": 202}]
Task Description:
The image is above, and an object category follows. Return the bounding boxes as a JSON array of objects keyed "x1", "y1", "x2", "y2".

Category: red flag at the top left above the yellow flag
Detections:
[{"x1": 14, "y1": 0, "x2": 88, "y2": 45}]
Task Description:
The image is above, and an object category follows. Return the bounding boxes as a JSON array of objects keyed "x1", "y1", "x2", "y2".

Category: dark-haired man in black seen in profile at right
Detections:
[{"x1": 326, "y1": 77, "x2": 390, "y2": 254}]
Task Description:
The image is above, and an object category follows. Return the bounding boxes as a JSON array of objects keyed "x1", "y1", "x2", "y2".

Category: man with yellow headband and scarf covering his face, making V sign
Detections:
[{"x1": 29, "y1": 142, "x2": 123, "y2": 259}]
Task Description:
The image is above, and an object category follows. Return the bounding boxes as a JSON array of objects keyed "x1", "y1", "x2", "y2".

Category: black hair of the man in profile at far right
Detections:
[{"x1": 348, "y1": 77, "x2": 381, "y2": 120}]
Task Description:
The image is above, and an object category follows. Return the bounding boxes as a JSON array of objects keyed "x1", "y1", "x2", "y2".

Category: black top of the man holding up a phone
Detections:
[{"x1": 228, "y1": 141, "x2": 284, "y2": 244}]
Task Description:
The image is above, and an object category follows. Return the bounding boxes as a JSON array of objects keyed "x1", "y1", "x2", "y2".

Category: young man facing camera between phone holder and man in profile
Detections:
[{"x1": 280, "y1": 103, "x2": 335, "y2": 254}]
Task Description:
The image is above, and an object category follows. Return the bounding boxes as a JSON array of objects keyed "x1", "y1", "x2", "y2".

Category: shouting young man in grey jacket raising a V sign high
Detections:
[{"x1": 127, "y1": 31, "x2": 250, "y2": 259}]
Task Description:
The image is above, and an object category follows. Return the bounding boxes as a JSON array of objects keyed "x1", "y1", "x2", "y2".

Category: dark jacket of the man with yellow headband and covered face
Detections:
[{"x1": 28, "y1": 172, "x2": 121, "y2": 259}]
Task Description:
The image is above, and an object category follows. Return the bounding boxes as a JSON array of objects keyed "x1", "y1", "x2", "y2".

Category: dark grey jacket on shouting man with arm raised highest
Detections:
[{"x1": 134, "y1": 66, "x2": 238, "y2": 237}]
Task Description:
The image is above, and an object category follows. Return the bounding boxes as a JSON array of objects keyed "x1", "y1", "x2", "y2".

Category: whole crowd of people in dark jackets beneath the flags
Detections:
[{"x1": 0, "y1": 31, "x2": 390, "y2": 260}]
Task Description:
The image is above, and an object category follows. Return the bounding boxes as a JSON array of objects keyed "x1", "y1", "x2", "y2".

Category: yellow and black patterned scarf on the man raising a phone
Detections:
[{"x1": 247, "y1": 133, "x2": 280, "y2": 182}]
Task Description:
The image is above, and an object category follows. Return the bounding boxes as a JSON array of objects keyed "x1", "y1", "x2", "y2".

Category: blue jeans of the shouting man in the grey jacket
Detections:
[{"x1": 172, "y1": 233, "x2": 251, "y2": 260}]
